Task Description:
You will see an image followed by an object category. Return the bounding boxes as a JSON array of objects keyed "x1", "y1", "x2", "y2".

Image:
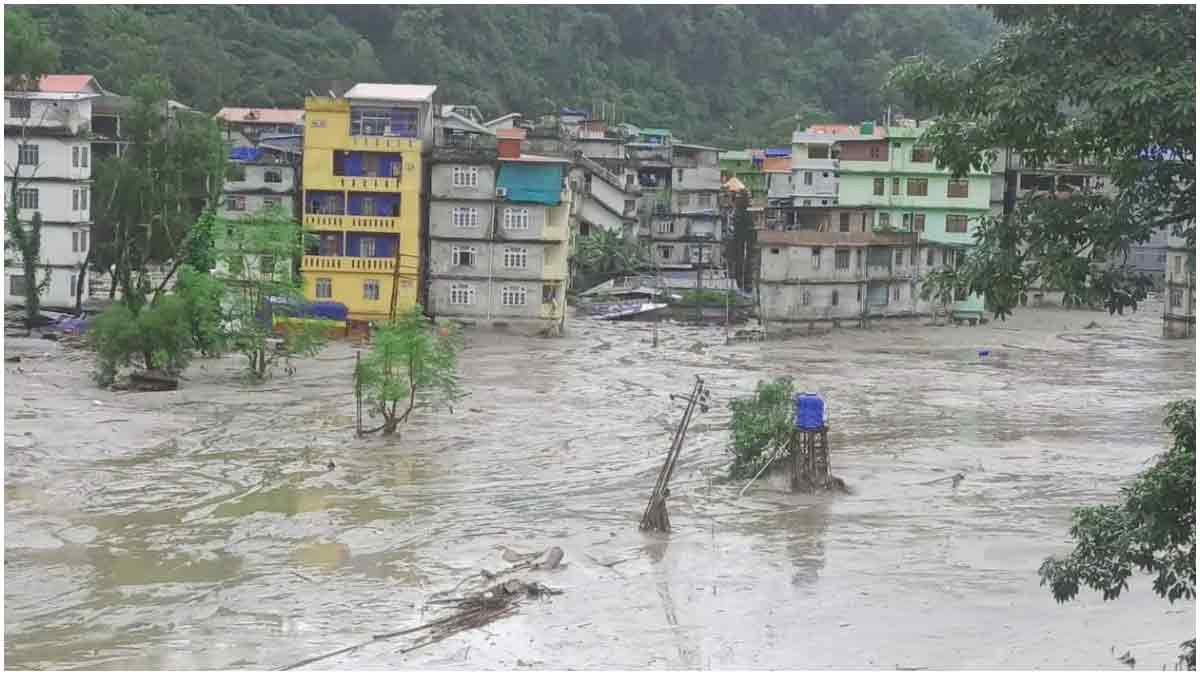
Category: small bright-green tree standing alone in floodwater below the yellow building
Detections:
[{"x1": 355, "y1": 306, "x2": 463, "y2": 435}]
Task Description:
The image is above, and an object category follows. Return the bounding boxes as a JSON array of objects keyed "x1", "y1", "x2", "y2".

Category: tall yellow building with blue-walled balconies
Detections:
[{"x1": 300, "y1": 84, "x2": 437, "y2": 322}]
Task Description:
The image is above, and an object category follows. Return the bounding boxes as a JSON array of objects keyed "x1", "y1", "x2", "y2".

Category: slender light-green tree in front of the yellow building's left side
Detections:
[{"x1": 216, "y1": 208, "x2": 331, "y2": 380}]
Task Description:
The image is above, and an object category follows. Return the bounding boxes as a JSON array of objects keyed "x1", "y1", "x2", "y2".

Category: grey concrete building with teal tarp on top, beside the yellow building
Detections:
[{"x1": 428, "y1": 129, "x2": 571, "y2": 334}]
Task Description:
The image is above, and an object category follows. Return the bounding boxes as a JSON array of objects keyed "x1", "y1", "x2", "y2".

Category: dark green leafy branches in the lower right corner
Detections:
[{"x1": 1038, "y1": 399, "x2": 1196, "y2": 669}]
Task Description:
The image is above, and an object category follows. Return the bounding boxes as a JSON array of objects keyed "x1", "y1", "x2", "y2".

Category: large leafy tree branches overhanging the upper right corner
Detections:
[{"x1": 890, "y1": 5, "x2": 1196, "y2": 317}]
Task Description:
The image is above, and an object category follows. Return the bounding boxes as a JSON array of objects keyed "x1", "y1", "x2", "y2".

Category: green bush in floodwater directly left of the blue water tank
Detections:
[{"x1": 730, "y1": 377, "x2": 796, "y2": 478}]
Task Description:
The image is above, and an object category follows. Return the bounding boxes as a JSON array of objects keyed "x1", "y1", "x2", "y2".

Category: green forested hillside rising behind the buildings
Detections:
[{"x1": 16, "y1": 5, "x2": 995, "y2": 147}]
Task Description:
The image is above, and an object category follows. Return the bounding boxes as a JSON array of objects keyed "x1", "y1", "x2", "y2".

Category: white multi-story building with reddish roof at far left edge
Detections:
[{"x1": 5, "y1": 74, "x2": 108, "y2": 307}]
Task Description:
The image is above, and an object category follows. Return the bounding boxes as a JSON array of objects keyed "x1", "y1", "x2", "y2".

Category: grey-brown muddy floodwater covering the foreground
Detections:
[{"x1": 4, "y1": 305, "x2": 1195, "y2": 670}]
